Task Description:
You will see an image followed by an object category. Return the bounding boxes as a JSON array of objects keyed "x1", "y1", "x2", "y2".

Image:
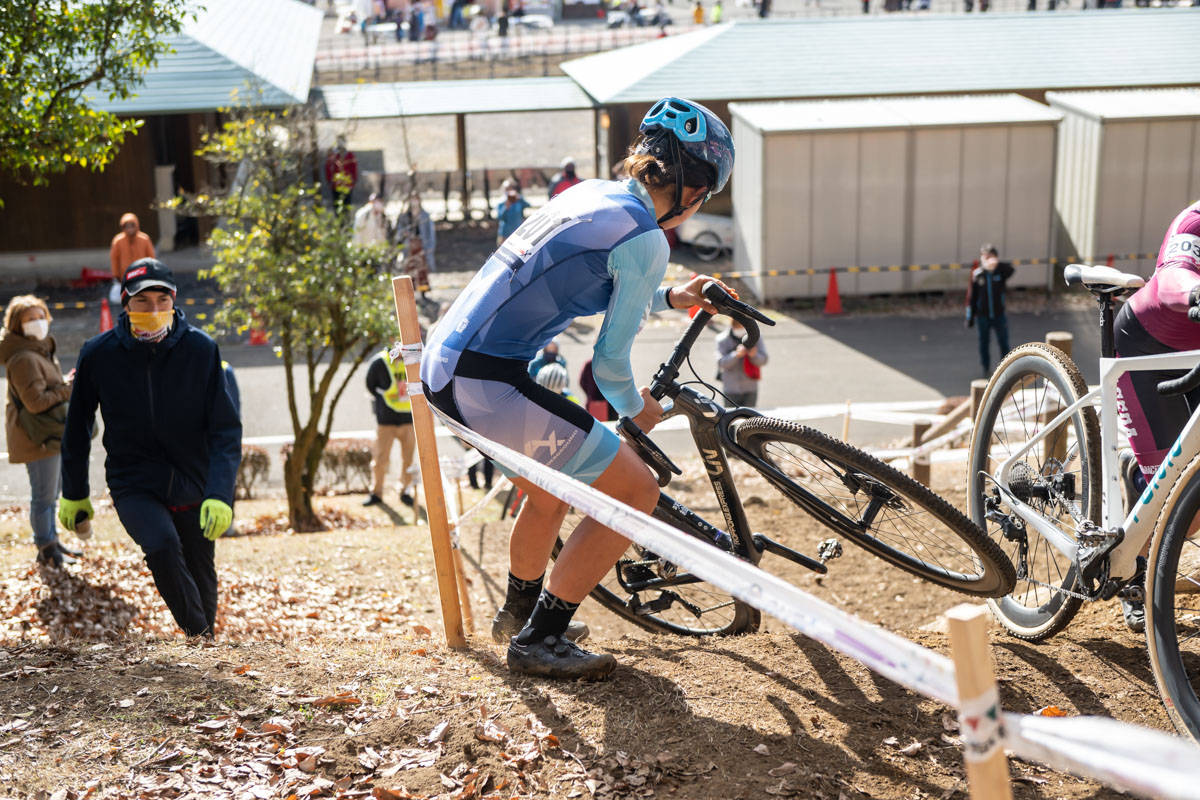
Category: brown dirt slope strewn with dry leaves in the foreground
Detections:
[{"x1": 0, "y1": 450, "x2": 1169, "y2": 800}]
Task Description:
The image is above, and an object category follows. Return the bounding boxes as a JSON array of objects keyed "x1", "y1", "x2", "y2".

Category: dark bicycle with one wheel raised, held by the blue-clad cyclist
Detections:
[{"x1": 554, "y1": 282, "x2": 1016, "y2": 636}]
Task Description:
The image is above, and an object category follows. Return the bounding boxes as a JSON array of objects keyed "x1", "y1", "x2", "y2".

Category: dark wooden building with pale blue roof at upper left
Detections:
[{"x1": 0, "y1": 0, "x2": 323, "y2": 266}]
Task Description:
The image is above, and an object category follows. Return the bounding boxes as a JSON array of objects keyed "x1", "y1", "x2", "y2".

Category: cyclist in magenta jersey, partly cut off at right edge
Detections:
[{"x1": 1114, "y1": 201, "x2": 1200, "y2": 633}]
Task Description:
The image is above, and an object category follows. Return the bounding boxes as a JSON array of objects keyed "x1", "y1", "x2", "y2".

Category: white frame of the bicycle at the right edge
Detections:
[{"x1": 992, "y1": 350, "x2": 1200, "y2": 581}]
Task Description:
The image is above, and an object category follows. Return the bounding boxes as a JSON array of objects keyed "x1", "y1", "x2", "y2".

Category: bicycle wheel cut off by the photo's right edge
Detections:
[{"x1": 1146, "y1": 464, "x2": 1200, "y2": 741}]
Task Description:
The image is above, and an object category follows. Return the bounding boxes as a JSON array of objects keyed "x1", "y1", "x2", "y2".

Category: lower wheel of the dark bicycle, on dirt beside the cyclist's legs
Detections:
[{"x1": 553, "y1": 500, "x2": 762, "y2": 636}]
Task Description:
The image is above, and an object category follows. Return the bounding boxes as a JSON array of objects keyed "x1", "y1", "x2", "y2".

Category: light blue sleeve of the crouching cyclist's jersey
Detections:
[{"x1": 592, "y1": 230, "x2": 668, "y2": 416}]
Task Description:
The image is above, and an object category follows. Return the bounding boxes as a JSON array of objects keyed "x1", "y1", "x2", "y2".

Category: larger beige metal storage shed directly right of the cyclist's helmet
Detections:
[{"x1": 730, "y1": 95, "x2": 1063, "y2": 299}]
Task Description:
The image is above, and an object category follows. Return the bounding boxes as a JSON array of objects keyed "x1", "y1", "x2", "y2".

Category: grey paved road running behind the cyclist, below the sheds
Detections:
[{"x1": 0, "y1": 299, "x2": 1098, "y2": 500}]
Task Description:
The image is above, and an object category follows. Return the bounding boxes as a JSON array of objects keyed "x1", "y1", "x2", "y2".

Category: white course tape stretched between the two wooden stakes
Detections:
[{"x1": 434, "y1": 409, "x2": 958, "y2": 705}]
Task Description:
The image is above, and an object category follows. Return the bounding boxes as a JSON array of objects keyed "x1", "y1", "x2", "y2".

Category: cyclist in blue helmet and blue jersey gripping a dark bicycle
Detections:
[{"x1": 421, "y1": 97, "x2": 733, "y2": 679}]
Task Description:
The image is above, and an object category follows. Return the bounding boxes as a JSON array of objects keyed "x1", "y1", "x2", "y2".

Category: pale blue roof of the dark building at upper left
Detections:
[{"x1": 92, "y1": 0, "x2": 323, "y2": 114}]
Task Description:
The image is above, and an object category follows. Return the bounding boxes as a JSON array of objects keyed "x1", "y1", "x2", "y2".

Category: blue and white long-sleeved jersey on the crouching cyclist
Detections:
[{"x1": 421, "y1": 180, "x2": 668, "y2": 416}]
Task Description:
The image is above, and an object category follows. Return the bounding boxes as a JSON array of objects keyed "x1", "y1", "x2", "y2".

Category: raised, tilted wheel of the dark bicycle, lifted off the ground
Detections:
[{"x1": 736, "y1": 416, "x2": 1015, "y2": 597}]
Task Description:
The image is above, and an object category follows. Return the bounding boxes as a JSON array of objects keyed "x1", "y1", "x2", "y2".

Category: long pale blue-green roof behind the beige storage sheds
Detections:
[{"x1": 563, "y1": 8, "x2": 1200, "y2": 104}]
